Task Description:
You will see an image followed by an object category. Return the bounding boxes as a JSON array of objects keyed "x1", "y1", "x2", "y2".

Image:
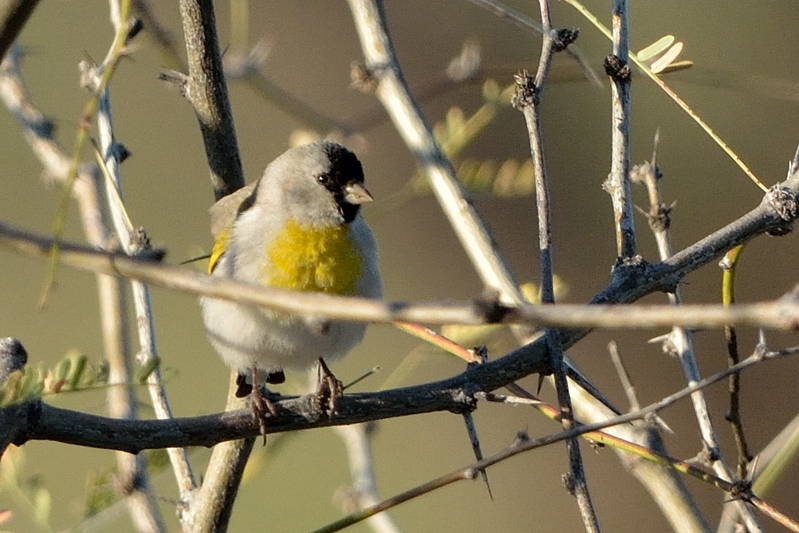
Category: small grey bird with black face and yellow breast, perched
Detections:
[{"x1": 200, "y1": 141, "x2": 383, "y2": 428}]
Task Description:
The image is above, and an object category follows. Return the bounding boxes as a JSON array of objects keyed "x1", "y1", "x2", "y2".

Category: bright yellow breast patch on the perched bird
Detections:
[{"x1": 263, "y1": 221, "x2": 363, "y2": 295}]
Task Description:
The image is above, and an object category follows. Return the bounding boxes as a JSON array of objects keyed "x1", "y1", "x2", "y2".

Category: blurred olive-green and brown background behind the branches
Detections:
[{"x1": 0, "y1": 0, "x2": 799, "y2": 532}]
